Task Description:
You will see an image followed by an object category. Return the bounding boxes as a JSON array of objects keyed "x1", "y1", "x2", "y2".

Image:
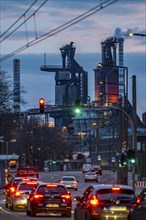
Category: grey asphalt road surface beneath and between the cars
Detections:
[{"x1": 0, "y1": 171, "x2": 116, "y2": 220}]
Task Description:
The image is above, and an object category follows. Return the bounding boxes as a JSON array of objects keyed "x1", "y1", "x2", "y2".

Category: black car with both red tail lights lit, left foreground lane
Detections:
[{"x1": 26, "y1": 183, "x2": 72, "y2": 217}]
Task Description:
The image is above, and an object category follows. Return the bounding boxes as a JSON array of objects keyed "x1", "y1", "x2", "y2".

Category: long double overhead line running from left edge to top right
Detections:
[{"x1": 0, "y1": 0, "x2": 118, "y2": 62}]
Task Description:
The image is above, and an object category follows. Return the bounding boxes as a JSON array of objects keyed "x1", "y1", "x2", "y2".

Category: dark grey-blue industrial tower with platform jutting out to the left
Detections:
[{"x1": 40, "y1": 42, "x2": 88, "y2": 105}]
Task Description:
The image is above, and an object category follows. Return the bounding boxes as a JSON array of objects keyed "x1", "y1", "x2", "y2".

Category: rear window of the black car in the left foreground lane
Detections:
[{"x1": 37, "y1": 186, "x2": 67, "y2": 194}]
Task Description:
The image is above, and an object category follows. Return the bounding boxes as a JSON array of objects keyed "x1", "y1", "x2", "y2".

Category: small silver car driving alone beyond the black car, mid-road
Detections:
[{"x1": 60, "y1": 176, "x2": 78, "y2": 191}]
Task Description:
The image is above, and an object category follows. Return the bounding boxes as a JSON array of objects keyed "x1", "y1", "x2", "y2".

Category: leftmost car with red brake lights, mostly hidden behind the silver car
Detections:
[{"x1": 5, "y1": 177, "x2": 38, "y2": 208}]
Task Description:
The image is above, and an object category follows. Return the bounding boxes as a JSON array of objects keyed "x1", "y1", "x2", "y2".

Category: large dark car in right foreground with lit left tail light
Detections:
[{"x1": 74, "y1": 184, "x2": 136, "y2": 220}]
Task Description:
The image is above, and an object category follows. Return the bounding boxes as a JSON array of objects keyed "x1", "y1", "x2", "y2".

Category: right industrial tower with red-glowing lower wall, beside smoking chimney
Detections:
[{"x1": 94, "y1": 37, "x2": 128, "y2": 106}]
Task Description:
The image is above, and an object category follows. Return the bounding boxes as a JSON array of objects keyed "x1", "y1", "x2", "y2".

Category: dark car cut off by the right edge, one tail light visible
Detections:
[{"x1": 129, "y1": 188, "x2": 146, "y2": 220}]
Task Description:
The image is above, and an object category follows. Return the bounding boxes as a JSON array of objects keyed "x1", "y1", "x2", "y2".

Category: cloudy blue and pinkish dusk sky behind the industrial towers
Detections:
[{"x1": 0, "y1": 0, "x2": 146, "y2": 118}]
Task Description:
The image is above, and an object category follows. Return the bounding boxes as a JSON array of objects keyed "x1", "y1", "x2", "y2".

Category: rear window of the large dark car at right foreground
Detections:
[{"x1": 96, "y1": 189, "x2": 135, "y2": 200}]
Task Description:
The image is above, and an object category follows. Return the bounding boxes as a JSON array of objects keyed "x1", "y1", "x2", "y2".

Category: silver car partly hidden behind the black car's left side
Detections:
[{"x1": 10, "y1": 181, "x2": 38, "y2": 211}]
